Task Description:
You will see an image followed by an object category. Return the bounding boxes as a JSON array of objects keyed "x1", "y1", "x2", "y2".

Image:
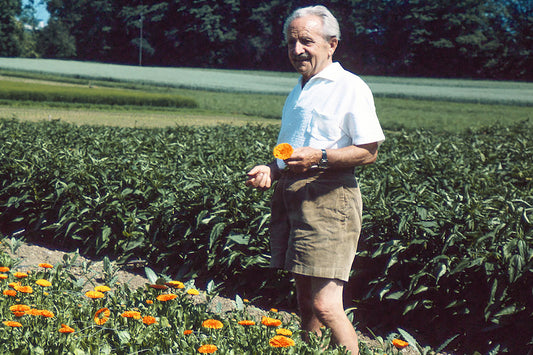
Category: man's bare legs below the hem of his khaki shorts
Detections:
[{"x1": 294, "y1": 275, "x2": 359, "y2": 355}]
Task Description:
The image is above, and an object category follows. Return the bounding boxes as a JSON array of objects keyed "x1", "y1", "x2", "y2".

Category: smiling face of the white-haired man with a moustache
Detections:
[{"x1": 287, "y1": 15, "x2": 338, "y2": 83}]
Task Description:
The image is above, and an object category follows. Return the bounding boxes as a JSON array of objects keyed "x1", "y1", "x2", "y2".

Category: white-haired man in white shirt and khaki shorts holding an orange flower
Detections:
[{"x1": 246, "y1": 6, "x2": 385, "y2": 354}]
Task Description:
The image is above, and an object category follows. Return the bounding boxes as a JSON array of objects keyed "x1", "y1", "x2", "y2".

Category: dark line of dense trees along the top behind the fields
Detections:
[{"x1": 0, "y1": 0, "x2": 533, "y2": 80}]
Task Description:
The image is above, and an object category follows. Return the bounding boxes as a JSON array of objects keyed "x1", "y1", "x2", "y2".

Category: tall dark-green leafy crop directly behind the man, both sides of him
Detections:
[{"x1": 0, "y1": 120, "x2": 533, "y2": 351}]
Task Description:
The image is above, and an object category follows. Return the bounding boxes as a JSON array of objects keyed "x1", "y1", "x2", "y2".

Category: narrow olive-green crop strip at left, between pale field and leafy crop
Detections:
[{"x1": 0, "y1": 81, "x2": 198, "y2": 108}]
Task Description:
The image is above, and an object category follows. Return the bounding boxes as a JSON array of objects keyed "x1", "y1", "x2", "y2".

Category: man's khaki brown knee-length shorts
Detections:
[{"x1": 270, "y1": 170, "x2": 363, "y2": 281}]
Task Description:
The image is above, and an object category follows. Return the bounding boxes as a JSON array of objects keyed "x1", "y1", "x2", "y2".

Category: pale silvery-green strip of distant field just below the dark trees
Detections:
[{"x1": 0, "y1": 58, "x2": 533, "y2": 106}]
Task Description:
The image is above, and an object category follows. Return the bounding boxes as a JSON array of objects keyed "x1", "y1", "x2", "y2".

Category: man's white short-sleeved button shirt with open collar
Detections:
[{"x1": 278, "y1": 62, "x2": 385, "y2": 168}]
